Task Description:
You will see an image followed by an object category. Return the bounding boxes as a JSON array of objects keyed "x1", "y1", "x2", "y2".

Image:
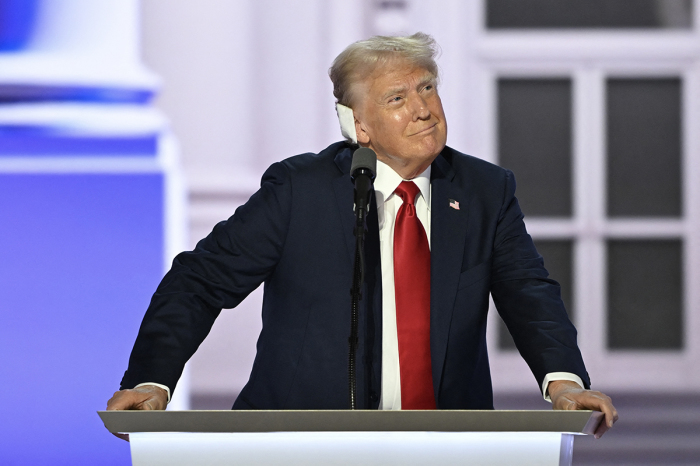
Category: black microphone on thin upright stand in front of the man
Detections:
[{"x1": 348, "y1": 147, "x2": 377, "y2": 409}]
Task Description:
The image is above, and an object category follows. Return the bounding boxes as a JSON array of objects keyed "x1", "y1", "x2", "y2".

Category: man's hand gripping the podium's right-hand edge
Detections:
[{"x1": 547, "y1": 380, "x2": 618, "y2": 438}]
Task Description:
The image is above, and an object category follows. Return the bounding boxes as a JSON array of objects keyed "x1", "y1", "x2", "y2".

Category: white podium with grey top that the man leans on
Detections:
[{"x1": 98, "y1": 410, "x2": 603, "y2": 466}]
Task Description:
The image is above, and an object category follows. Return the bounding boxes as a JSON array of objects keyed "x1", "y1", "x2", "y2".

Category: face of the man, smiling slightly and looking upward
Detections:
[{"x1": 353, "y1": 60, "x2": 447, "y2": 179}]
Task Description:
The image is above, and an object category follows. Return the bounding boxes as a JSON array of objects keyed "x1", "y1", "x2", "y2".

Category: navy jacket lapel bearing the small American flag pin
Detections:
[{"x1": 430, "y1": 155, "x2": 469, "y2": 400}]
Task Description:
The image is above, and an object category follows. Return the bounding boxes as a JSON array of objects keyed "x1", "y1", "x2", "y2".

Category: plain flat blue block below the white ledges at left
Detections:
[{"x1": 0, "y1": 173, "x2": 163, "y2": 465}]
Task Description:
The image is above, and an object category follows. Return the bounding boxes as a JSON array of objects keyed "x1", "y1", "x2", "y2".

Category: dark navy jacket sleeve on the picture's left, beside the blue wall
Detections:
[{"x1": 121, "y1": 163, "x2": 291, "y2": 393}]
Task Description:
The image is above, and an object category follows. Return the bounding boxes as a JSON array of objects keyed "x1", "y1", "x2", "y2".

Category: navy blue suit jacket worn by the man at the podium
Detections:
[{"x1": 122, "y1": 142, "x2": 589, "y2": 409}]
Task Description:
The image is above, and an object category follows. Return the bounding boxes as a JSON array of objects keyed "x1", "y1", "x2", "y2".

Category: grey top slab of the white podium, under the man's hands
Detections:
[{"x1": 98, "y1": 410, "x2": 602, "y2": 434}]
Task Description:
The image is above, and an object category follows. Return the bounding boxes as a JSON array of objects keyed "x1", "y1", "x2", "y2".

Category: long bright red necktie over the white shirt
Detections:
[{"x1": 394, "y1": 181, "x2": 435, "y2": 409}]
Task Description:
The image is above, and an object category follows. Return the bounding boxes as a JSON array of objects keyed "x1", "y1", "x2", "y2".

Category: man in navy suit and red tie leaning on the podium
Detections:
[{"x1": 108, "y1": 33, "x2": 617, "y2": 436}]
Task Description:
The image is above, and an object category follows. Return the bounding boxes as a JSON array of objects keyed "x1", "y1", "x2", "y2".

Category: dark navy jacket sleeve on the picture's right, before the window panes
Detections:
[{"x1": 491, "y1": 170, "x2": 590, "y2": 388}]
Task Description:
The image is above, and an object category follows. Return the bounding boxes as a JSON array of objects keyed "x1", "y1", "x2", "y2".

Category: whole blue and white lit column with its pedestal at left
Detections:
[{"x1": 0, "y1": 0, "x2": 184, "y2": 466}]
